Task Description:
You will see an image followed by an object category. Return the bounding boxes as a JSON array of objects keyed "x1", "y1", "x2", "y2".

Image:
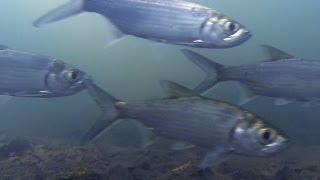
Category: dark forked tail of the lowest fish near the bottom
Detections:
[{"x1": 81, "y1": 82, "x2": 120, "y2": 144}]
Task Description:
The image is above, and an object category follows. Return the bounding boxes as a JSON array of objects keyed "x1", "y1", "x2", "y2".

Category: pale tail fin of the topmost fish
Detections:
[{"x1": 33, "y1": 0, "x2": 85, "y2": 27}]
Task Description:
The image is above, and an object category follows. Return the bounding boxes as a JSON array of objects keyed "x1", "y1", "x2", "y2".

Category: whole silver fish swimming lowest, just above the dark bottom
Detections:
[{"x1": 83, "y1": 81, "x2": 288, "y2": 168}]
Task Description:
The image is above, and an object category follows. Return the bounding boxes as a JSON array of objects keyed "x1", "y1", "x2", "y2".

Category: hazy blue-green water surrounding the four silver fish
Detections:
[{"x1": 0, "y1": 0, "x2": 320, "y2": 150}]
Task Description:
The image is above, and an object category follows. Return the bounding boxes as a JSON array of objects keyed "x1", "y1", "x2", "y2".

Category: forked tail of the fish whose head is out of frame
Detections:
[{"x1": 181, "y1": 49, "x2": 223, "y2": 94}]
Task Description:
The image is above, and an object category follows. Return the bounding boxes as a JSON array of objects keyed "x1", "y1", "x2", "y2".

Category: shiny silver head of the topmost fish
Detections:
[{"x1": 200, "y1": 13, "x2": 252, "y2": 48}]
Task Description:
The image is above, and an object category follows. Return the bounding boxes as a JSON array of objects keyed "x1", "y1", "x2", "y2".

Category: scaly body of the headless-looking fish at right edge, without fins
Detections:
[{"x1": 220, "y1": 59, "x2": 320, "y2": 102}]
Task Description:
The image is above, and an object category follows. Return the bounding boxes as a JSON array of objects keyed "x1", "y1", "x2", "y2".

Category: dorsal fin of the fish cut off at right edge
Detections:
[{"x1": 261, "y1": 44, "x2": 295, "y2": 61}]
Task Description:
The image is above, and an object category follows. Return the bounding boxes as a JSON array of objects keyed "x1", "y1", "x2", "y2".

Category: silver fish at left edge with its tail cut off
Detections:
[{"x1": 0, "y1": 45, "x2": 90, "y2": 97}]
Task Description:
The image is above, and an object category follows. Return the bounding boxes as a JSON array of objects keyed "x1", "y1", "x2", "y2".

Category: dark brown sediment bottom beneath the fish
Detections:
[{"x1": 0, "y1": 138, "x2": 320, "y2": 180}]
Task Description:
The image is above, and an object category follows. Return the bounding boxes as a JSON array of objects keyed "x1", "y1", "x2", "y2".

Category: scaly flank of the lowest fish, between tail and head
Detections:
[{"x1": 116, "y1": 97, "x2": 245, "y2": 149}]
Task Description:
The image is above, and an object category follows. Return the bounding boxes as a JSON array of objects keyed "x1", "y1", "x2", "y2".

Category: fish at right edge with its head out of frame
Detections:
[{"x1": 182, "y1": 45, "x2": 320, "y2": 105}]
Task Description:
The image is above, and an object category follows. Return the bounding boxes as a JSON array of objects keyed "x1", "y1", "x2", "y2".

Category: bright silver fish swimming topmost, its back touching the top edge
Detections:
[{"x1": 34, "y1": 0, "x2": 251, "y2": 48}]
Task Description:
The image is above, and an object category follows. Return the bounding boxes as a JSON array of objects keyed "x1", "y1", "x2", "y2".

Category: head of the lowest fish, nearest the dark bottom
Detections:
[{"x1": 231, "y1": 113, "x2": 289, "y2": 156}]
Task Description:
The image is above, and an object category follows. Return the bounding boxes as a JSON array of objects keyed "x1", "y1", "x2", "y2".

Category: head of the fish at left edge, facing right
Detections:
[{"x1": 45, "y1": 60, "x2": 90, "y2": 96}]
